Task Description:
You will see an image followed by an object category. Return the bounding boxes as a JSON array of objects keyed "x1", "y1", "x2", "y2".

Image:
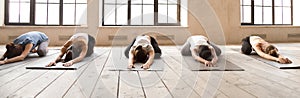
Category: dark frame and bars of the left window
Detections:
[{"x1": 4, "y1": 0, "x2": 87, "y2": 26}]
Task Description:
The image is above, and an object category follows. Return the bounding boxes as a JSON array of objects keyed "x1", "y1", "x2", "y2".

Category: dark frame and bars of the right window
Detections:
[{"x1": 240, "y1": 0, "x2": 293, "y2": 25}]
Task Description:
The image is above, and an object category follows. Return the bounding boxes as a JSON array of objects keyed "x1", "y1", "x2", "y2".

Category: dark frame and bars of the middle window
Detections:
[{"x1": 101, "y1": 0, "x2": 181, "y2": 26}]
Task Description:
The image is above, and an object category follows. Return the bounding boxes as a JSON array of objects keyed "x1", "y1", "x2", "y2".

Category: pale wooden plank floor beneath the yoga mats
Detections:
[{"x1": 0, "y1": 43, "x2": 300, "y2": 98}]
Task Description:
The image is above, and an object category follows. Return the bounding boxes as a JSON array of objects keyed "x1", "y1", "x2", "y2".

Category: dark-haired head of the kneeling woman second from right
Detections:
[{"x1": 199, "y1": 45, "x2": 211, "y2": 60}]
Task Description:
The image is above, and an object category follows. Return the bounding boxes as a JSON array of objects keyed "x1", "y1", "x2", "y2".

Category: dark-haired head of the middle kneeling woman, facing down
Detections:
[{"x1": 134, "y1": 46, "x2": 148, "y2": 63}]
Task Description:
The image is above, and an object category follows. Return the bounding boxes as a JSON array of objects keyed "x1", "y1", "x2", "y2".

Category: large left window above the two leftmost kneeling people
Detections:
[{"x1": 5, "y1": 0, "x2": 87, "y2": 25}]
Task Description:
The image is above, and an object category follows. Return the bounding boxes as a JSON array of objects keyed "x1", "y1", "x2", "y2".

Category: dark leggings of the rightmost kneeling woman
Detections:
[{"x1": 241, "y1": 36, "x2": 252, "y2": 55}]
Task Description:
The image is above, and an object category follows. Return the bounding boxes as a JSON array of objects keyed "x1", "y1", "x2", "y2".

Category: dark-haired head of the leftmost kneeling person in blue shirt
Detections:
[{"x1": 6, "y1": 43, "x2": 24, "y2": 59}]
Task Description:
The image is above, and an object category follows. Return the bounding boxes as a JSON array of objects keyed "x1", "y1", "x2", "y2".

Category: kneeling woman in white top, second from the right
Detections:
[{"x1": 181, "y1": 35, "x2": 221, "y2": 67}]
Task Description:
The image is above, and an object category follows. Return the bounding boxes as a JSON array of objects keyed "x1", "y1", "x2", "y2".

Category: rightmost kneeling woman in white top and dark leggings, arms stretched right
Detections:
[{"x1": 241, "y1": 36, "x2": 292, "y2": 64}]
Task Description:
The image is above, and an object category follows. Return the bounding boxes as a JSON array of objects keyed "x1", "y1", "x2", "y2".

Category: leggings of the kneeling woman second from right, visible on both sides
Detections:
[{"x1": 181, "y1": 41, "x2": 222, "y2": 56}]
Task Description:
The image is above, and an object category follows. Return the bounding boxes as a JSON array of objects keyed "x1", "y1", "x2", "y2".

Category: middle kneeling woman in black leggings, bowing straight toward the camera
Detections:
[{"x1": 125, "y1": 35, "x2": 161, "y2": 69}]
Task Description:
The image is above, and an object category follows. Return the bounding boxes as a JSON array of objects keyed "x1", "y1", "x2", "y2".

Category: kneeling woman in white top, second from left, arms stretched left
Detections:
[{"x1": 47, "y1": 33, "x2": 95, "y2": 67}]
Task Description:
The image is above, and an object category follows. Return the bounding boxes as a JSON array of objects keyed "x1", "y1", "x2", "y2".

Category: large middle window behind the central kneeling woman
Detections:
[{"x1": 102, "y1": 0, "x2": 180, "y2": 26}]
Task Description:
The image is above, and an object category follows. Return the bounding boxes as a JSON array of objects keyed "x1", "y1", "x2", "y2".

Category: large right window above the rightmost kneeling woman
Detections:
[{"x1": 240, "y1": 0, "x2": 293, "y2": 25}]
